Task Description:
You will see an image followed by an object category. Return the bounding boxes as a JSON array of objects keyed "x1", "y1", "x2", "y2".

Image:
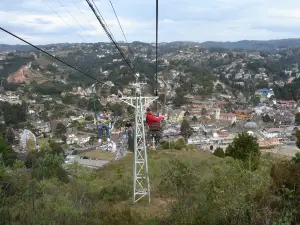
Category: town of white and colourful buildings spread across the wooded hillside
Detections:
[{"x1": 0, "y1": 42, "x2": 300, "y2": 161}]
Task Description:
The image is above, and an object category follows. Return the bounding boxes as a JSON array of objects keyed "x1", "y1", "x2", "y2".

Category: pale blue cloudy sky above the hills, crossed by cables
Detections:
[{"x1": 0, "y1": 0, "x2": 300, "y2": 44}]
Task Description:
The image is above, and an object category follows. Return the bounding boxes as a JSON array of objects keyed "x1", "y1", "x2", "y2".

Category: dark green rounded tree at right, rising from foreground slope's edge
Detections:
[{"x1": 225, "y1": 132, "x2": 260, "y2": 170}]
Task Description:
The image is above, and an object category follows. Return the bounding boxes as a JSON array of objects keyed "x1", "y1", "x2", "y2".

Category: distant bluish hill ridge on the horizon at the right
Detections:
[{"x1": 201, "y1": 38, "x2": 300, "y2": 52}]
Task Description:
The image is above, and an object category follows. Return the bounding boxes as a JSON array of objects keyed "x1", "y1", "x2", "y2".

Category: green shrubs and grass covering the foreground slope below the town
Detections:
[{"x1": 0, "y1": 134, "x2": 300, "y2": 225}]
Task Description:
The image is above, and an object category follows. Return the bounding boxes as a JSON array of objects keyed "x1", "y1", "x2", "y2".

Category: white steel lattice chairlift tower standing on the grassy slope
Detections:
[{"x1": 121, "y1": 73, "x2": 158, "y2": 204}]
